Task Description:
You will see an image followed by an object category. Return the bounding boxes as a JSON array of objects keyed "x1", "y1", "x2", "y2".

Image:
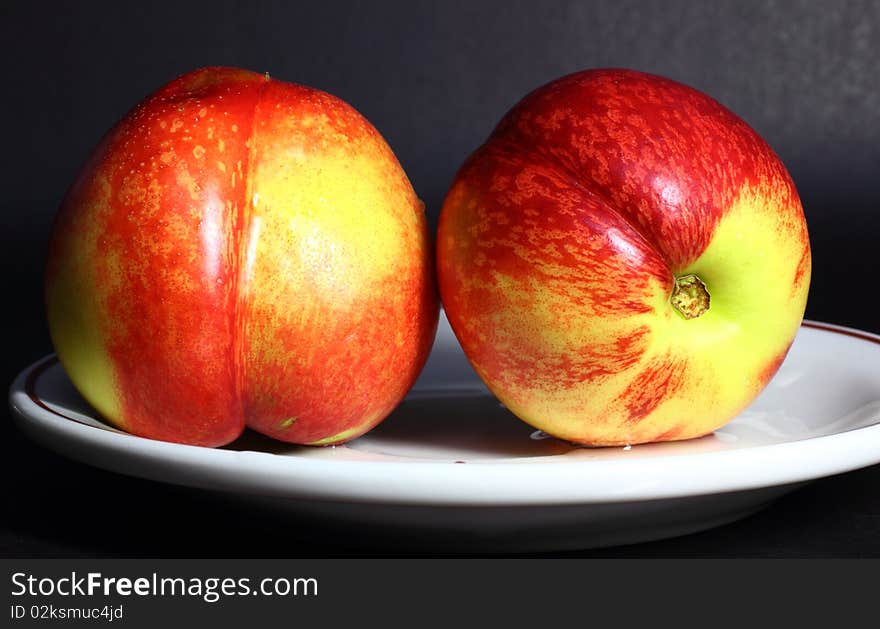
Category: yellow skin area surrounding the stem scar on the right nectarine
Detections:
[{"x1": 473, "y1": 179, "x2": 810, "y2": 445}]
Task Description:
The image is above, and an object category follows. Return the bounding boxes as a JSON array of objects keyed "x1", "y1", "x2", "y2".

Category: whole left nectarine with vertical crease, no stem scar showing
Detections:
[{"x1": 45, "y1": 68, "x2": 438, "y2": 446}]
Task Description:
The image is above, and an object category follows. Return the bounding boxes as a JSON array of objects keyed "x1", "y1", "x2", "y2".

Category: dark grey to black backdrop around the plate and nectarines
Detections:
[{"x1": 0, "y1": 0, "x2": 880, "y2": 556}]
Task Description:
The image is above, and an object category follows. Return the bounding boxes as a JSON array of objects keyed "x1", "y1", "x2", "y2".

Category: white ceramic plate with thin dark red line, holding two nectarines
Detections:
[{"x1": 10, "y1": 317, "x2": 880, "y2": 552}]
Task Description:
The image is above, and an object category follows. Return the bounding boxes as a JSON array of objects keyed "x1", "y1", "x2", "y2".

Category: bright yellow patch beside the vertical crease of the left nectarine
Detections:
[{"x1": 243, "y1": 121, "x2": 418, "y2": 361}]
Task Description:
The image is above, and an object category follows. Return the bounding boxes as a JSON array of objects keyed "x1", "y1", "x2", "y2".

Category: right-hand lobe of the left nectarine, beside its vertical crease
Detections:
[{"x1": 240, "y1": 92, "x2": 428, "y2": 445}]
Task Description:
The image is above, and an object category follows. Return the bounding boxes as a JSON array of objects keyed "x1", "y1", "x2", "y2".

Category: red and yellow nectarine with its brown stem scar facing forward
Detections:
[{"x1": 437, "y1": 70, "x2": 811, "y2": 445}]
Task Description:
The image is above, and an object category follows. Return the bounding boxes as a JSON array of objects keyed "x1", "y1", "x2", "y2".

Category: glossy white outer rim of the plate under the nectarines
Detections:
[{"x1": 9, "y1": 319, "x2": 880, "y2": 507}]
